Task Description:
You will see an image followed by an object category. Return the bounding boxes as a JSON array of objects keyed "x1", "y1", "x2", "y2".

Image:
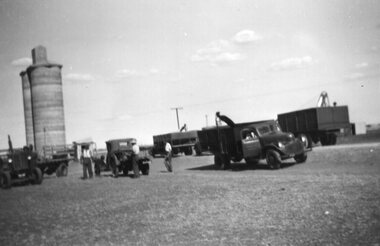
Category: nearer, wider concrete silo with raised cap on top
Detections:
[{"x1": 27, "y1": 46, "x2": 66, "y2": 151}]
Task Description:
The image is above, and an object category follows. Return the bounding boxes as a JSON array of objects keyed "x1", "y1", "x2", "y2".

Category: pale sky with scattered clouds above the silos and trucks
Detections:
[{"x1": 0, "y1": 0, "x2": 380, "y2": 149}]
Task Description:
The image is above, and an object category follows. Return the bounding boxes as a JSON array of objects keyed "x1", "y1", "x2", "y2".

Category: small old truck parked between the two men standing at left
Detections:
[{"x1": 101, "y1": 138, "x2": 151, "y2": 177}]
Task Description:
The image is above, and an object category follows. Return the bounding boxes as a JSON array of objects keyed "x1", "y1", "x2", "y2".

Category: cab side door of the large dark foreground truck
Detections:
[{"x1": 240, "y1": 128, "x2": 261, "y2": 158}]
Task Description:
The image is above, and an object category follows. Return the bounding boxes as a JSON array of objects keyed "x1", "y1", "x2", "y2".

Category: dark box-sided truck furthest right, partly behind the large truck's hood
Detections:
[{"x1": 277, "y1": 106, "x2": 351, "y2": 148}]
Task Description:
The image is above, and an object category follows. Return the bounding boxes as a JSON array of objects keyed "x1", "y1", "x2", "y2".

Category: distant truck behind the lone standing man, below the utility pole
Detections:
[{"x1": 152, "y1": 130, "x2": 202, "y2": 156}]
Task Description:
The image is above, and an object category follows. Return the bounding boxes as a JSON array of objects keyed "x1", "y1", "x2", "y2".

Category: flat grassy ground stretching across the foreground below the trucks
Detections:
[{"x1": 0, "y1": 142, "x2": 380, "y2": 245}]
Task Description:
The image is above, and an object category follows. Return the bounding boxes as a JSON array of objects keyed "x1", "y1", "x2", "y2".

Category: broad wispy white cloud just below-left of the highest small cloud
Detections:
[{"x1": 191, "y1": 39, "x2": 243, "y2": 65}]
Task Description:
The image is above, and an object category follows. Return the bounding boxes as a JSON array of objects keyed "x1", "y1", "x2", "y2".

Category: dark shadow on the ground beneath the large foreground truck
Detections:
[{"x1": 187, "y1": 162, "x2": 296, "y2": 172}]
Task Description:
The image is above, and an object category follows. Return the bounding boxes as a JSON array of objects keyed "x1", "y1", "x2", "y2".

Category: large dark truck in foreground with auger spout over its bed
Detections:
[{"x1": 199, "y1": 112, "x2": 310, "y2": 169}]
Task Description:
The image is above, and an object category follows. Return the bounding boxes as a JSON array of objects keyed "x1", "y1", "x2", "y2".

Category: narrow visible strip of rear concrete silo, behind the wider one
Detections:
[{"x1": 20, "y1": 71, "x2": 34, "y2": 146}]
